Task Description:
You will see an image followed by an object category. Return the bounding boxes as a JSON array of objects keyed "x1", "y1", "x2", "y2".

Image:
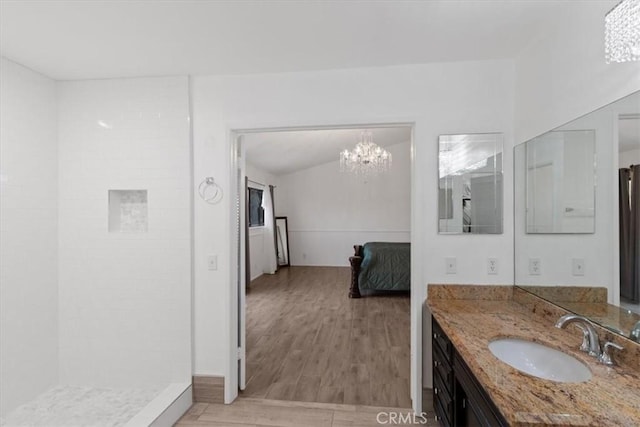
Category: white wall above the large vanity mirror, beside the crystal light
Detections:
[{"x1": 515, "y1": 0, "x2": 640, "y2": 144}]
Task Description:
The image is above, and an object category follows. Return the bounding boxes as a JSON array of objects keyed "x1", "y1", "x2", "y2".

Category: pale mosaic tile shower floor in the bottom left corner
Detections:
[{"x1": 0, "y1": 386, "x2": 161, "y2": 427}]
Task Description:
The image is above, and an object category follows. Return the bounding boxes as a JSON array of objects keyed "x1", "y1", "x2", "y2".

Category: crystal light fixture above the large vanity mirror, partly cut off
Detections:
[{"x1": 604, "y1": 0, "x2": 640, "y2": 64}]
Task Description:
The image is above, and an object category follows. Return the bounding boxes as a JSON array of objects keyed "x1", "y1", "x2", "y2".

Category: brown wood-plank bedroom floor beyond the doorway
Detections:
[{"x1": 241, "y1": 267, "x2": 411, "y2": 408}]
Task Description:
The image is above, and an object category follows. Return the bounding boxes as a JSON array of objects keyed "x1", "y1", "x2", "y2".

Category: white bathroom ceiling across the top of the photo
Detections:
[{"x1": 0, "y1": 0, "x2": 584, "y2": 80}]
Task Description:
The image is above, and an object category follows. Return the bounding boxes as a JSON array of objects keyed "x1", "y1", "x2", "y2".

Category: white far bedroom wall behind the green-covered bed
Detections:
[{"x1": 277, "y1": 141, "x2": 411, "y2": 266}]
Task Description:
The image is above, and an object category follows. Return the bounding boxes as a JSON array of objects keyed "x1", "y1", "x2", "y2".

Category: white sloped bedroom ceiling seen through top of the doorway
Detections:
[{"x1": 243, "y1": 126, "x2": 411, "y2": 175}]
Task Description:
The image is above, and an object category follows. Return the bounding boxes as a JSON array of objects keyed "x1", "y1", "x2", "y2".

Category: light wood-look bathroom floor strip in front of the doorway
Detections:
[{"x1": 176, "y1": 397, "x2": 436, "y2": 427}]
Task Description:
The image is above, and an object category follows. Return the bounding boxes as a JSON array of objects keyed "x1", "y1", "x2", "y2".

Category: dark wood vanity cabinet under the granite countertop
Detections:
[{"x1": 431, "y1": 317, "x2": 508, "y2": 427}]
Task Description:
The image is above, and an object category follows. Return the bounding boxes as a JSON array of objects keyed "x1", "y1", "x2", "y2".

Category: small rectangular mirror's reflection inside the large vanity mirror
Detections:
[{"x1": 525, "y1": 129, "x2": 595, "y2": 233}]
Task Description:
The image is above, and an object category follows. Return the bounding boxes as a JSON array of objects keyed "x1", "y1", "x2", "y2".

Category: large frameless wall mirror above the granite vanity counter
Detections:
[{"x1": 514, "y1": 92, "x2": 640, "y2": 337}]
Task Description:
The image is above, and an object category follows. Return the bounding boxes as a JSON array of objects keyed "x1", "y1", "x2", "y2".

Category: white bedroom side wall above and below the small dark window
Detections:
[{"x1": 245, "y1": 159, "x2": 279, "y2": 280}]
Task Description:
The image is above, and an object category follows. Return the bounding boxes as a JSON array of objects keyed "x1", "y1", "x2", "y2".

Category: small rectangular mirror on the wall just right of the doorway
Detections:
[{"x1": 438, "y1": 133, "x2": 503, "y2": 234}]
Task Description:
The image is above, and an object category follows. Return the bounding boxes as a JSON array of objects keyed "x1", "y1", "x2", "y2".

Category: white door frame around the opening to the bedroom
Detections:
[{"x1": 224, "y1": 118, "x2": 423, "y2": 413}]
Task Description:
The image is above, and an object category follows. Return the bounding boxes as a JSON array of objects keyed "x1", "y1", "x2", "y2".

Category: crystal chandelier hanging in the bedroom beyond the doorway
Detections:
[{"x1": 340, "y1": 130, "x2": 392, "y2": 175}]
